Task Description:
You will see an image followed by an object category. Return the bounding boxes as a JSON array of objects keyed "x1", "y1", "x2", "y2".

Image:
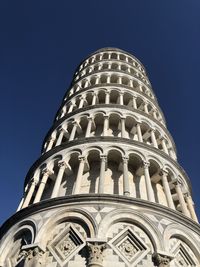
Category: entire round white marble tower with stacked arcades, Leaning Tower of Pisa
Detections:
[{"x1": 0, "y1": 48, "x2": 200, "y2": 267}]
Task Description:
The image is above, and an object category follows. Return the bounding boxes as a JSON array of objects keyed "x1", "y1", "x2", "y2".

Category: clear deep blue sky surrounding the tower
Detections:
[{"x1": 0, "y1": 0, "x2": 200, "y2": 223}]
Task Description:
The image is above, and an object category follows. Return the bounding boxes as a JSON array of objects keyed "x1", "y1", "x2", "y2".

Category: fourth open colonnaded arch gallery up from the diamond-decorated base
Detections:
[{"x1": 64, "y1": 72, "x2": 154, "y2": 100}]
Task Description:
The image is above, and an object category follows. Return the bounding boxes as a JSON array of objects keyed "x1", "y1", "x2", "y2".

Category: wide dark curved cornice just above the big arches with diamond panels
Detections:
[{"x1": 0, "y1": 194, "x2": 200, "y2": 239}]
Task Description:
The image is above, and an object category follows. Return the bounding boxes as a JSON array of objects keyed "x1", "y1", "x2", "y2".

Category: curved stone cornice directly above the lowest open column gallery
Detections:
[{"x1": 28, "y1": 136, "x2": 187, "y2": 191}]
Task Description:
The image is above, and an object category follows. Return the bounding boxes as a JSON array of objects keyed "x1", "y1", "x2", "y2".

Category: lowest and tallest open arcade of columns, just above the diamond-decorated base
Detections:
[{"x1": 20, "y1": 144, "x2": 197, "y2": 224}]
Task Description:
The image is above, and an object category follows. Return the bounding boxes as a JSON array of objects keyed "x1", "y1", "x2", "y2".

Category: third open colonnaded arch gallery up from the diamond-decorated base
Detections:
[{"x1": 56, "y1": 88, "x2": 165, "y2": 124}]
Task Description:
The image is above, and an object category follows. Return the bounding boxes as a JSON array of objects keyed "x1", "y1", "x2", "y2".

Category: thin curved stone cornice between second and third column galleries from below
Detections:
[{"x1": 42, "y1": 104, "x2": 173, "y2": 152}]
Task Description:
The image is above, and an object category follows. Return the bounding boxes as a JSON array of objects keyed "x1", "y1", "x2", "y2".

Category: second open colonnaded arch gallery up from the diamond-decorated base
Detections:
[{"x1": 43, "y1": 109, "x2": 176, "y2": 160}]
